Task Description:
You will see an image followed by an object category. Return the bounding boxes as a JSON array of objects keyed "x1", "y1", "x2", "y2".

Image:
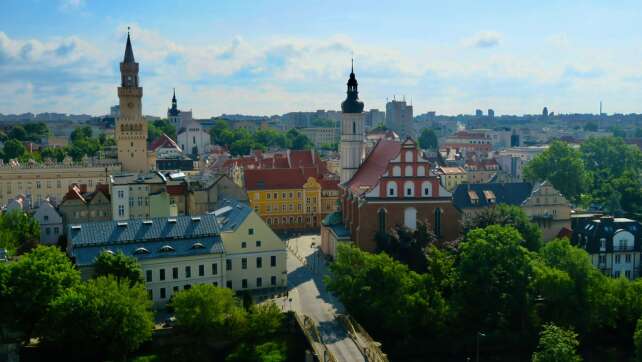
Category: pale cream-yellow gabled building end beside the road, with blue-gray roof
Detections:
[{"x1": 214, "y1": 199, "x2": 287, "y2": 290}]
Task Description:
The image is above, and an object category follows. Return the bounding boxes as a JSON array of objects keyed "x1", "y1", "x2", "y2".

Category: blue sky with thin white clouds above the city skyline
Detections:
[{"x1": 0, "y1": 0, "x2": 642, "y2": 118}]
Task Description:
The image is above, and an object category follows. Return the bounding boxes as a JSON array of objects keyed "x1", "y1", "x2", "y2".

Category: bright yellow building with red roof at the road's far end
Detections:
[{"x1": 244, "y1": 169, "x2": 339, "y2": 230}]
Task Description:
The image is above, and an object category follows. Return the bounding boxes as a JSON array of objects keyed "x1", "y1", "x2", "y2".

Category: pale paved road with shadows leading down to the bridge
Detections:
[{"x1": 287, "y1": 235, "x2": 365, "y2": 362}]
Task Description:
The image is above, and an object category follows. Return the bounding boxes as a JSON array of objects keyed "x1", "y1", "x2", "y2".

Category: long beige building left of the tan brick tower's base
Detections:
[{"x1": 0, "y1": 158, "x2": 120, "y2": 205}]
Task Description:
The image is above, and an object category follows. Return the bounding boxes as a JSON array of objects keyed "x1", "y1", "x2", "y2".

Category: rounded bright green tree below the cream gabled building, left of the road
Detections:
[{"x1": 172, "y1": 284, "x2": 246, "y2": 338}]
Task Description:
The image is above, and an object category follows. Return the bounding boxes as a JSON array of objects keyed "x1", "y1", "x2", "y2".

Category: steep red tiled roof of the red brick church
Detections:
[{"x1": 346, "y1": 139, "x2": 401, "y2": 192}]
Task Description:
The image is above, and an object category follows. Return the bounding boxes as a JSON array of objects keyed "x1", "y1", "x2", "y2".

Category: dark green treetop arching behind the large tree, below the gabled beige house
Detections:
[{"x1": 465, "y1": 204, "x2": 542, "y2": 251}]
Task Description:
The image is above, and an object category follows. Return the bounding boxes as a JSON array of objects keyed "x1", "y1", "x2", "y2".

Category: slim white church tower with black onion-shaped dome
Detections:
[{"x1": 340, "y1": 61, "x2": 365, "y2": 184}]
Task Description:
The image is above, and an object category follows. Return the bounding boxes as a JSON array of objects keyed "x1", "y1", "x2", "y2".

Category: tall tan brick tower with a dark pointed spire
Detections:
[{"x1": 114, "y1": 32, "x2": 148, "y2": 172}]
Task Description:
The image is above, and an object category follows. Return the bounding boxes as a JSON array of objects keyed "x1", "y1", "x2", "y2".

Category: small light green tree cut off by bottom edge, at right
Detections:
[{"x1": 532, "y1": 324, "x2": 582, "y2": 362}]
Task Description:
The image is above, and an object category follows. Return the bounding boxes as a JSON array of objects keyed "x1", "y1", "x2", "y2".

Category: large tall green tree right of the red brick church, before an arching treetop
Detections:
[{"x1": 455, "y1": 225, "x2": 532, "y2": 338}]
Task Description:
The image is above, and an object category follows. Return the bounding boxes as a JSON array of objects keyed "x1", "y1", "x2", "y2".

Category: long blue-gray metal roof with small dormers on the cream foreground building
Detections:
[{"x1": 68, "y1": 215, "x2": 224, "y2": 266}]
